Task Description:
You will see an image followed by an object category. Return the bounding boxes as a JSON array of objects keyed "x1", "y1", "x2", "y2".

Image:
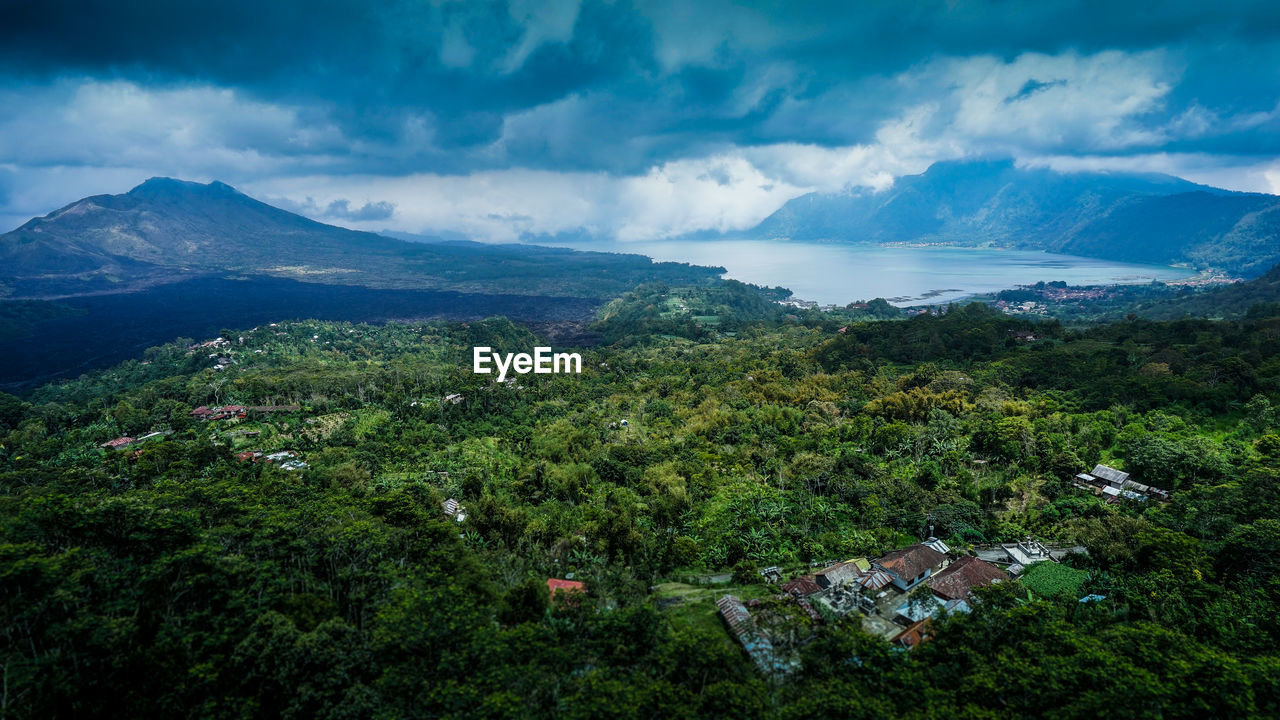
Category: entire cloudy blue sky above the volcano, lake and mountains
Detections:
[{"x1": 0, "y1": 0, "x2": 1280, "y2": 242}]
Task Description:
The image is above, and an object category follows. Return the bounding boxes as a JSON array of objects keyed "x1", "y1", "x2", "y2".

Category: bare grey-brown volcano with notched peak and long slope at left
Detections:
[{"x1": 0, "y1": 178, "x2": 718, "y2": 297}]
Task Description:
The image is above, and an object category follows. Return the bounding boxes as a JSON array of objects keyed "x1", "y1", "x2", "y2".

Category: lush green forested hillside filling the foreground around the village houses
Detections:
[{"x1": 0, "y1": 283, "x2": 1280, "y2": 719}]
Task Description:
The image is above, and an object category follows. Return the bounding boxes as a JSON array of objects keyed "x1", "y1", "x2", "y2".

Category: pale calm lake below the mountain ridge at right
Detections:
[{"x1": 604, "y1": 240, "x2": 1192, "y2": 305}]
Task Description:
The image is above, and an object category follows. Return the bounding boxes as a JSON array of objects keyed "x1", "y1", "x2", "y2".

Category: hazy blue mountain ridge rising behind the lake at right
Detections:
[{"x1": 749, "y1": 161, "x2": 1280, "y2": 275}]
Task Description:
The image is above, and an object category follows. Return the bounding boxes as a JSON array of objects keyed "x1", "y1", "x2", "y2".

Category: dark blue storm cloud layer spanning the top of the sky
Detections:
[{"x1": 0, "y1": 0, "x2": 1280, "y2": 172}]
